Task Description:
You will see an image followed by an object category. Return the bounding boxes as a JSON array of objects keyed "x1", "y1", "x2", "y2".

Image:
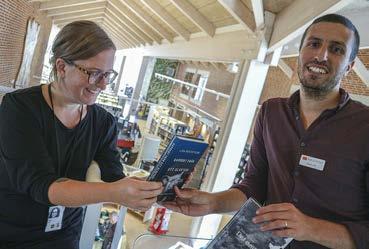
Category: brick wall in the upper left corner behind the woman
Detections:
[{"x1": 0, "y1": 0, "x2": 51, "y2": 89}]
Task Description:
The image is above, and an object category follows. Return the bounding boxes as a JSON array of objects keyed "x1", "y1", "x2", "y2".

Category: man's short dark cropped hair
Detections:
[{"x1": 299, "y1": 14, "x2": 360, "y2": 61}]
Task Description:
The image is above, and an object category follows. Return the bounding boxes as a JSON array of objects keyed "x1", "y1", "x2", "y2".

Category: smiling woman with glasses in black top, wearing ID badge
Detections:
[{"x1": 0, "y1": 21, "x2": 162, "y2": 249}]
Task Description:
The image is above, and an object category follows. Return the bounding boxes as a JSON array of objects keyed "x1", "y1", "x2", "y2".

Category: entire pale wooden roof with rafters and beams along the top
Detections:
[{"x1": 29, "y1": 0, "x2": 369, "y2": 55}]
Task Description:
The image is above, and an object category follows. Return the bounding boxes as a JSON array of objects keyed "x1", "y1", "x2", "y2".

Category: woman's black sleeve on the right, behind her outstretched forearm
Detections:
[{"x1": 94, "y1": 113, "x2": 125, "y2": 182}]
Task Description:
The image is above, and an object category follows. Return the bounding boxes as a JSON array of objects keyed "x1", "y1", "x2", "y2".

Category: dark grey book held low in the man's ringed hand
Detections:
[{"x1": 206, "y1": 198, "x2": 292, "y2": 249}]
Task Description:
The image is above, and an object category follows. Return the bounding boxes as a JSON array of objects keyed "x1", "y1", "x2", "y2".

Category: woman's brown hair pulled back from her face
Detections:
[{"x1": 50, "y1": 21, "x2": 116, "y2": 81}]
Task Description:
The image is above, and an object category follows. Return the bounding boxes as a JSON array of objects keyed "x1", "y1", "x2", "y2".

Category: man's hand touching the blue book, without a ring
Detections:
[{"x1": 162, "y1": 187, "x2": 213, "y2": 216}]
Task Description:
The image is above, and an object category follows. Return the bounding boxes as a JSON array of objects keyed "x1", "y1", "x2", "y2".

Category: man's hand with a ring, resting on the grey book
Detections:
[{"x1": 253, "y1": 203, "x2": 314, "y2": 241}]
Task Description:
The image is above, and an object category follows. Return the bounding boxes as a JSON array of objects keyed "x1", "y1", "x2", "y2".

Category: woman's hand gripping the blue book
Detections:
[{"x1": 110, "y1": 177, "x2": 163, "y2": 211}]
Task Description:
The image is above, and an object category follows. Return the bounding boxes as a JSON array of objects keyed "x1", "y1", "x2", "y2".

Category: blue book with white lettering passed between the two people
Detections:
[{"x1": 147, "y1": 135, "x2": 208, "y2": 202}]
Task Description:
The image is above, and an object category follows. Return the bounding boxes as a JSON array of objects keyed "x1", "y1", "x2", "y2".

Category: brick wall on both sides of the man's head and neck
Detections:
[{"x1": 259, "y1": 49, "x2": 369, "y2": 103}]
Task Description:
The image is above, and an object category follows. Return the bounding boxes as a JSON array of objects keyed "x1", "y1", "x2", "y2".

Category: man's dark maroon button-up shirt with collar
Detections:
[{"x1": 233, "y1": 89, "x2": 369, "y2": 249}]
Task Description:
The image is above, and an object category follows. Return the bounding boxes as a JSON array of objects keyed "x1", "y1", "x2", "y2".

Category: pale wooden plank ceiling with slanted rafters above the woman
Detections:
[{"x1": 29, "y1": 0, "x2": 293, "y2": 49}]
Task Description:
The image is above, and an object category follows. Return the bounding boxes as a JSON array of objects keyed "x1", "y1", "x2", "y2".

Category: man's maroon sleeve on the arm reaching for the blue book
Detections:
[{"x1": 231, "y1": 104, "x2": 268, "y2": 203}]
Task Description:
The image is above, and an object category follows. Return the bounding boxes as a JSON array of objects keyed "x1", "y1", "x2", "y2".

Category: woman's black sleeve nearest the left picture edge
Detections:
[{"x1": 0, "y1": 94, "x2": 58, "y2": 205}]
